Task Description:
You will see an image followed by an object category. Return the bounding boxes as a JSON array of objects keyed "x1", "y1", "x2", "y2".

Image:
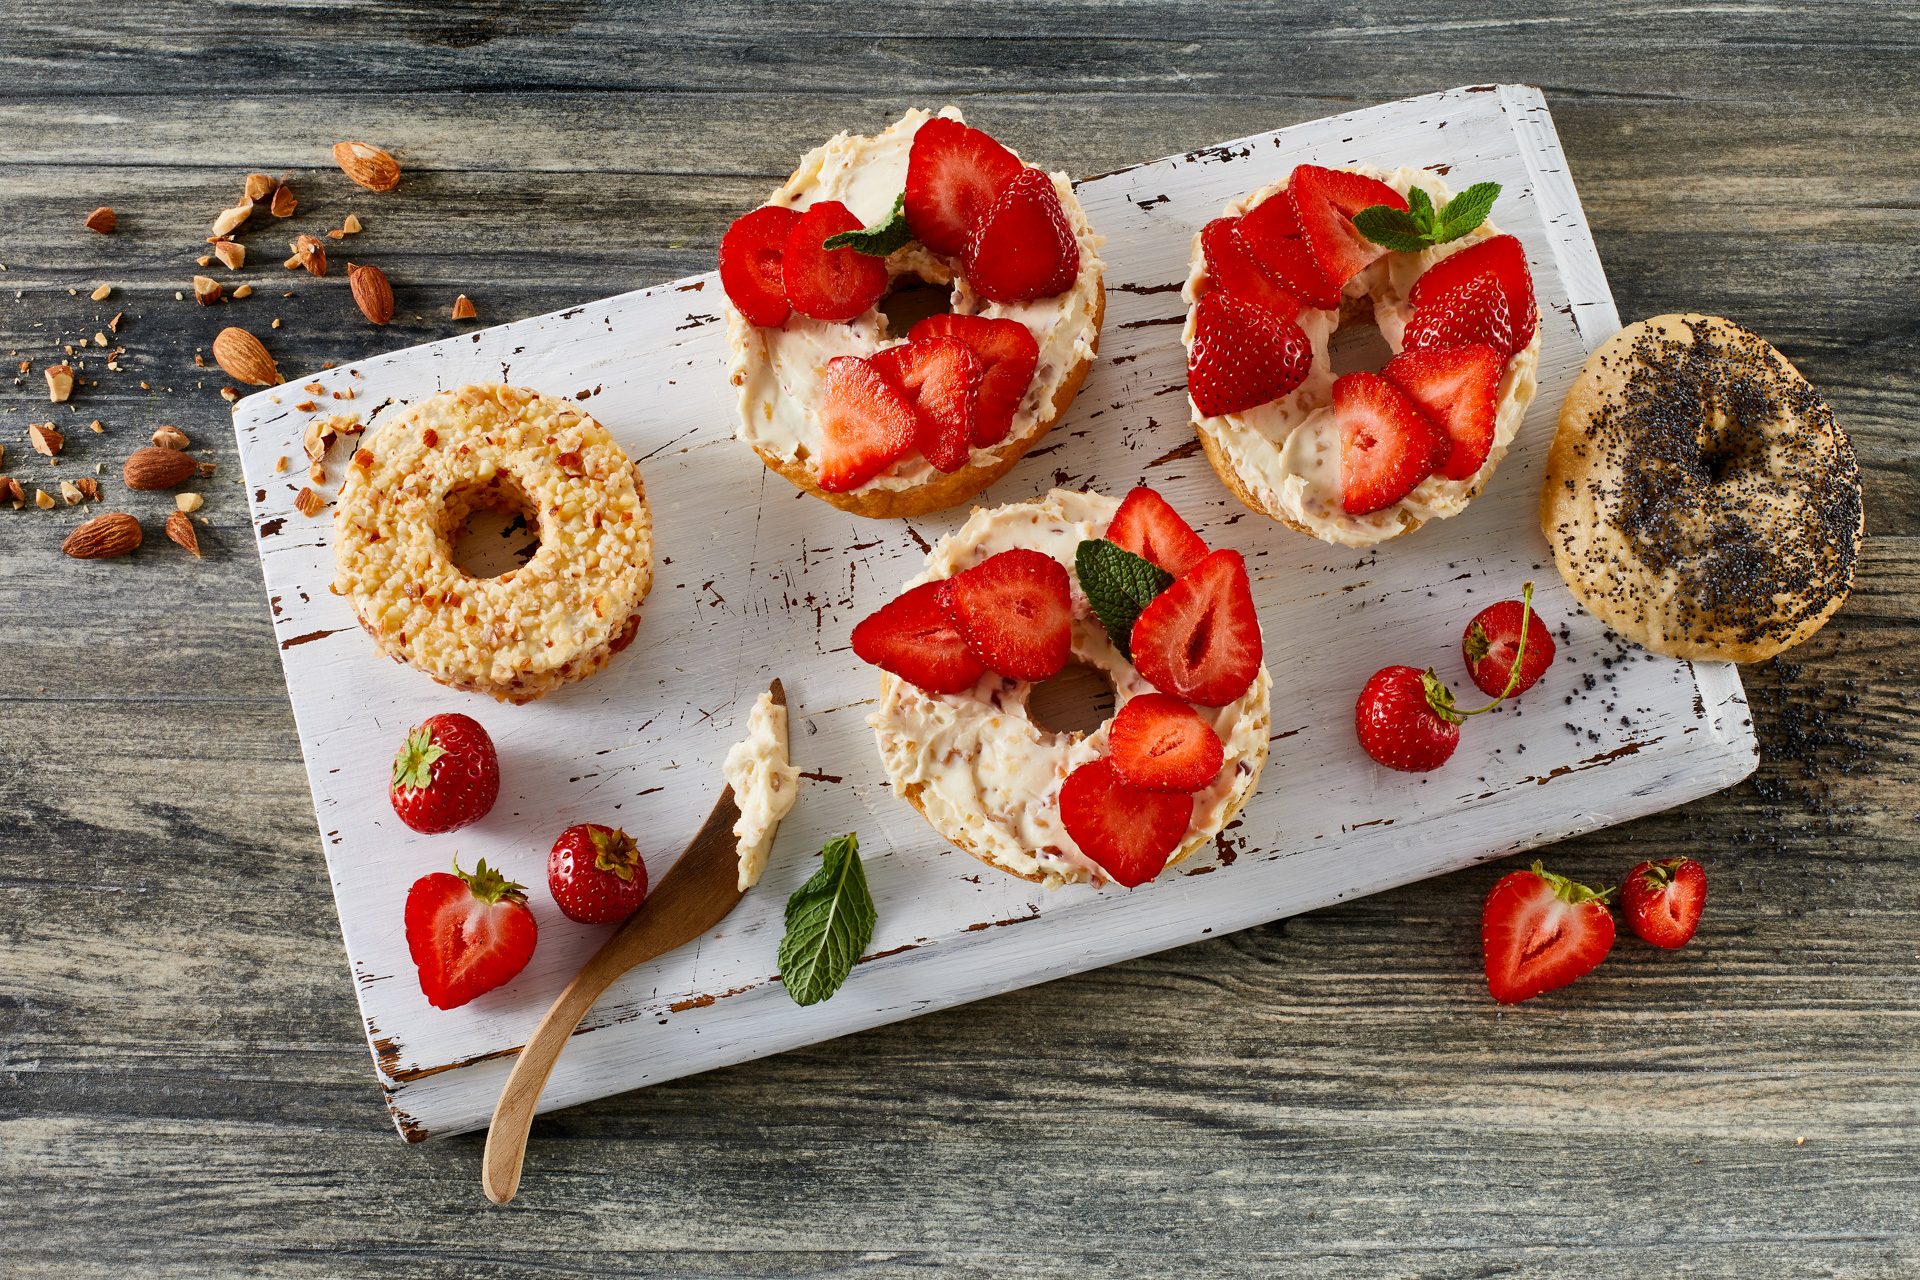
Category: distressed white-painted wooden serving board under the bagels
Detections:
[{"x1": 234, "y1": 86, "x2": 1757, "y2": 1140}]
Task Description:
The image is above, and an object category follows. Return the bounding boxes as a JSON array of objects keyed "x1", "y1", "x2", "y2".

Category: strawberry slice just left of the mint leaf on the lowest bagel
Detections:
[{"x1": 943, "y1": 547, "x2": 1073, "y2": 679}]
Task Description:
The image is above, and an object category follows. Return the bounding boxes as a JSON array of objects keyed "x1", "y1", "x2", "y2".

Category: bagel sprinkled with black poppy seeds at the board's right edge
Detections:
[{"x1": 1540, "y1": 315, "x2": 1864, "y2": 662}]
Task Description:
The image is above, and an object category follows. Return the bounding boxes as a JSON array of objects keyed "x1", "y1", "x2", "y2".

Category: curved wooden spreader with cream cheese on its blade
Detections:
[{"x1": 480, "y1": 679, "x2": 787, "y2": 1205}]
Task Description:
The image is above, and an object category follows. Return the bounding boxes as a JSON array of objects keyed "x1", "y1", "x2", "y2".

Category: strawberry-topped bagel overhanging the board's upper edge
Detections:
[{"x1": 720, "y1": 107, "x2": 1106, "y2": 516}]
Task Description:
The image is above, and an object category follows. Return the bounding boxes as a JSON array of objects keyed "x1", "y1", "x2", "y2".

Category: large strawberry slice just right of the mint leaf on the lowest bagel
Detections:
[{"x1": 1131, "y1": 551, "x2": 1261, "y2": 706}]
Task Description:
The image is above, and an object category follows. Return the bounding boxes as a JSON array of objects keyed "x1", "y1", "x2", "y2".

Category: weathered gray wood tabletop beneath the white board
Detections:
[{"x1": 0, "y1": 2, "x2": 1920, "y2": 1278}]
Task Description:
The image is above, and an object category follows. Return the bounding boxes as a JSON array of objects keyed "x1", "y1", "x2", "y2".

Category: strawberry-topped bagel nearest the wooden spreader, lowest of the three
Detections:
[{"x1": 852, "y1": 487, "x2": 1273, "y2": 889}]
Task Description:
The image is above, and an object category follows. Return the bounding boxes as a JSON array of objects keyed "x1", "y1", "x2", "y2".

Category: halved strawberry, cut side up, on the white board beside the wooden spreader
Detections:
[{"x1": 407, "y1": 858, "x2": 540, "y2": 1009}]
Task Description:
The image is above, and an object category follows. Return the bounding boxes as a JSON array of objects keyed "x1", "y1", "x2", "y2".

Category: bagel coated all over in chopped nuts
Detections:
[{"x1": 334, "y1": 384, "x2": 653, "y2": 702}]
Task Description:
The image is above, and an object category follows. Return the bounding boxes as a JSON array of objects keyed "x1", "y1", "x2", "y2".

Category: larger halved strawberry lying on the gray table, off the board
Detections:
[{"x1": 1480, "y1": 862, "x2": 1613, "y2": 1004}]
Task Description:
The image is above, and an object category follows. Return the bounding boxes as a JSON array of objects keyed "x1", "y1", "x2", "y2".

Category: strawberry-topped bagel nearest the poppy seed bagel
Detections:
[{"x1": 1183, "y1": 165, "x2": 1540, "y2": 547}]
